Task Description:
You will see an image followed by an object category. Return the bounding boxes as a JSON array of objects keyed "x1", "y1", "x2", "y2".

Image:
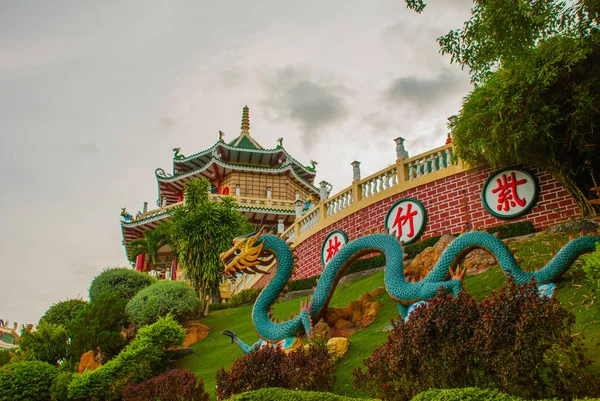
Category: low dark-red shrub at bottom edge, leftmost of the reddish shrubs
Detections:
[{"x1": 123, "y1": 369, "x2": 209, "y2": 401}]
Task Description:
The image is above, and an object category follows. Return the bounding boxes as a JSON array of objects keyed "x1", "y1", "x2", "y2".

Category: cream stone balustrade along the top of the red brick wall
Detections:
[{"x1": 283, "y1": 144, "x2": 464, "y2": 244}]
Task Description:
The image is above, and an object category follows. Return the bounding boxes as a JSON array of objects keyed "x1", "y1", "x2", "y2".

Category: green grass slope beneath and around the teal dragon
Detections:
[{"x1": 177, "y1": 235, "x2": 600, "y2": 397}]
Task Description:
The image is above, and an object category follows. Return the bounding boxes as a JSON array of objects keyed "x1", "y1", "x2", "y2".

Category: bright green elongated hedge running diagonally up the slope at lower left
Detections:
[{"x1": 69, "y1": 315, "x2": 185, "y2": 401}]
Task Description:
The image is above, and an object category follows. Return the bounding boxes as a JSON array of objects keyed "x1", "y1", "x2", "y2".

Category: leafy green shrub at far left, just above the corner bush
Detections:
[{"x1": 13, "y1": 321, "x2": 69, "y2": 365}]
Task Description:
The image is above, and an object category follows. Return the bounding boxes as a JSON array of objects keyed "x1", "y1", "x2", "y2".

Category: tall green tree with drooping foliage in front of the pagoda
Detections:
[{"x1": 170, "y1": 178, "x2": 253, "y2": 310}]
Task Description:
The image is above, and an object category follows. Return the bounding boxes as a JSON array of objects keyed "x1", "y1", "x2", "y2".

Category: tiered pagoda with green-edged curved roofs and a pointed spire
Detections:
[{"x1": 121, "y1": 106, "x2": 320, "y2": 279}]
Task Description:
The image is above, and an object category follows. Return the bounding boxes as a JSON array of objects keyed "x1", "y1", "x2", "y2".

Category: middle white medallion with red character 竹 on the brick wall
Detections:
[{"x1": 385, "y1": 198, "x2": 427, "y2": 244}]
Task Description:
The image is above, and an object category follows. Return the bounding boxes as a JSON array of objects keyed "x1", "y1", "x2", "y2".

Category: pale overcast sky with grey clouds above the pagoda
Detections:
[{"x1": 0, "y1": 0, "x2": 471, "y2": 323}]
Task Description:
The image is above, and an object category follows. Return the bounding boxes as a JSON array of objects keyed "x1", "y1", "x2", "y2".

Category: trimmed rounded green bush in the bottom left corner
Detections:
[{"x1": 0, "y1": 361, "x2": 58, "y2": 401}]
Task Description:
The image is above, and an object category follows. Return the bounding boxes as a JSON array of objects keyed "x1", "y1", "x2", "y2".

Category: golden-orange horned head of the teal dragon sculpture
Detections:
[{"x1": 220, "y1": 228, "x2": 275, "y2": 279}]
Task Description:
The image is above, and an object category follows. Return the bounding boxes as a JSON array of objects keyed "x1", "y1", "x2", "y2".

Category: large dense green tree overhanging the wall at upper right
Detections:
[{"x1": 406, "y1": 0, "x2": 600, "y2": 215}]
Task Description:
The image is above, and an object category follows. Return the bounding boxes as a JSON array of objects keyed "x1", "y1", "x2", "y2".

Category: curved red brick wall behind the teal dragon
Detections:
[{"x1": 292, "y1": 165, "x2": 579, "y2": 281}]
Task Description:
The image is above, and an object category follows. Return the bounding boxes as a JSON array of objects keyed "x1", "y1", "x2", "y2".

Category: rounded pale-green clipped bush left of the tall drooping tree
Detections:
[{"x1": 127, "y1": 281, "x2": 201, "y2": 326}]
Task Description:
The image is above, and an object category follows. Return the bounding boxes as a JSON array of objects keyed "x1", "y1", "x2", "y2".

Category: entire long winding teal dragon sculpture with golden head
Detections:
[{"x1": 221, "y1": 230, "x2": 600, "y2": 353}]
